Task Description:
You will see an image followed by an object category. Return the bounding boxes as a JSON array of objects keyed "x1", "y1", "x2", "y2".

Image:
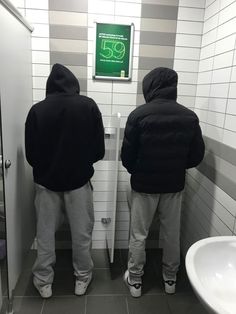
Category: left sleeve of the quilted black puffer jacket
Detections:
[{"x1": 121, "y1": 116, "x2": 139, "y2": 174}]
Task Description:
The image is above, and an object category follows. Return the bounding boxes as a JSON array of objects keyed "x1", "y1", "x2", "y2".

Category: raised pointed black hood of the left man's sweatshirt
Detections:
[{"x1": 46, "y1": 63, "x2": 80, "y2": 95}]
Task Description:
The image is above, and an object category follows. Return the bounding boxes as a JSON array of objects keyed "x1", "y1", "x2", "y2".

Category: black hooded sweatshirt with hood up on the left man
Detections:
[{"x1": 25, "y1": 64, "x2": 105, "y2": 192}]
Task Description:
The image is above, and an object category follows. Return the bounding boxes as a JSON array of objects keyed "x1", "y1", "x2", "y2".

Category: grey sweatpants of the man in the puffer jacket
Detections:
[{"x1": 128, "y1": 190, "x2": 182, "y2": 281}]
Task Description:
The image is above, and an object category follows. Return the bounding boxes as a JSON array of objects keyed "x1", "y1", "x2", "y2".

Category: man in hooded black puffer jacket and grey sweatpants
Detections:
[{"x1": 121, "y1": 68, "x2": 205, "y2": 297}]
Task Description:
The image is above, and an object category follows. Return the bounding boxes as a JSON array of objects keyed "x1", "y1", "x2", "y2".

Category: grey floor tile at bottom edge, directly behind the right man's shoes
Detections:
[{"x1": 128, "y1": 295, "x2": 171, "y2": 314}]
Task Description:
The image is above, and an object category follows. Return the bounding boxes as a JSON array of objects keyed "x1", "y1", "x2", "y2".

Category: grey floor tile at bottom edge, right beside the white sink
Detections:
[{"x1": 167, "y1": 293, "x2": 208, "y2": 314}]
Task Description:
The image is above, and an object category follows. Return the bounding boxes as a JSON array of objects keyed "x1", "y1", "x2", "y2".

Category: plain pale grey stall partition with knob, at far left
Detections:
[{"x1": 0, "y1": 1, "x2": 35, "y2": 298}]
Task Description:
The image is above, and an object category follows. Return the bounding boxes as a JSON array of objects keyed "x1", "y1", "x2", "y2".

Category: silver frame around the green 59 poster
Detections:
[{"x1": 93, "y1": 22, "x2": 134, "y2": 81}]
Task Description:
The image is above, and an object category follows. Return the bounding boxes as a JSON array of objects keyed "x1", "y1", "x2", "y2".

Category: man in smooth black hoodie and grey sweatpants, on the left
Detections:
[{"x1": 25, "y1": 64, "x2": 105, "y2": 298}]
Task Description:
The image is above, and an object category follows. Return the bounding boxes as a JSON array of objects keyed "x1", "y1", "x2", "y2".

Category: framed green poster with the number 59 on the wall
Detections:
[{"x1": 94, "y1": 23, "x2": 134, "y2": 80}]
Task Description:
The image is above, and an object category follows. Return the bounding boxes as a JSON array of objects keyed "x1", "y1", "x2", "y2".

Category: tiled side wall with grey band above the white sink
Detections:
[{"x1": 179, "y1": 0, "x2": 236, "y2": 252}]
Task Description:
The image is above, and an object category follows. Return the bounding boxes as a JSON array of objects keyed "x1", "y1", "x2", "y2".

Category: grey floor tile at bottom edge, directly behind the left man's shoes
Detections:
[{"x1": 42, "y1": 296, "x2": 85, "y2": 314}]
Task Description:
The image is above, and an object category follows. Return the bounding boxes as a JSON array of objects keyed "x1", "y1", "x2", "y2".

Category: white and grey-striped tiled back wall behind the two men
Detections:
[{"x1": 11, "y1": 0, "x2": 178, "y2": 248}]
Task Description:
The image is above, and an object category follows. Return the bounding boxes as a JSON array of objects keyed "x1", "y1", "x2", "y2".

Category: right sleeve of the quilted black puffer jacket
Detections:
[{"x1": 186, "y1": 121, "x2": 205, "y2": 169}]
